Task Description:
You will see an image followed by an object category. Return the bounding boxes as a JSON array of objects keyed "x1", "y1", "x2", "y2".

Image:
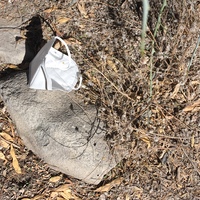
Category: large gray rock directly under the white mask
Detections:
[{"x1": 0, "y1": 73, "x2": 116, "y2": 184}]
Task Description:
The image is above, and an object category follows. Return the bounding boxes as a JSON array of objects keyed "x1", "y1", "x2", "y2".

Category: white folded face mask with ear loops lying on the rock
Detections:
[{"x1": 29, "y1": 36, "x2": 82, "y2": 92}]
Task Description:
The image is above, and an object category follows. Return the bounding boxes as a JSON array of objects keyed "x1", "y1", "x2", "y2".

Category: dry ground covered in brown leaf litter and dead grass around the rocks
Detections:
[{"x1": 0, "y1": 0, "x2": 200, "y2": 200}]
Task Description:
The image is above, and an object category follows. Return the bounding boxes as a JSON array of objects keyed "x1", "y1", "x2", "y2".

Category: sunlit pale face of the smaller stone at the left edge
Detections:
[{"x1": 0, "y1": 18, "x2": 26, "y2": 65}]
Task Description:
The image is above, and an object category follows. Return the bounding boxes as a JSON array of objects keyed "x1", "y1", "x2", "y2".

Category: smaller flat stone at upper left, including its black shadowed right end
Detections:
[{"x1": 0, "y1": 16, "x2": 42, "y2": 65}]
